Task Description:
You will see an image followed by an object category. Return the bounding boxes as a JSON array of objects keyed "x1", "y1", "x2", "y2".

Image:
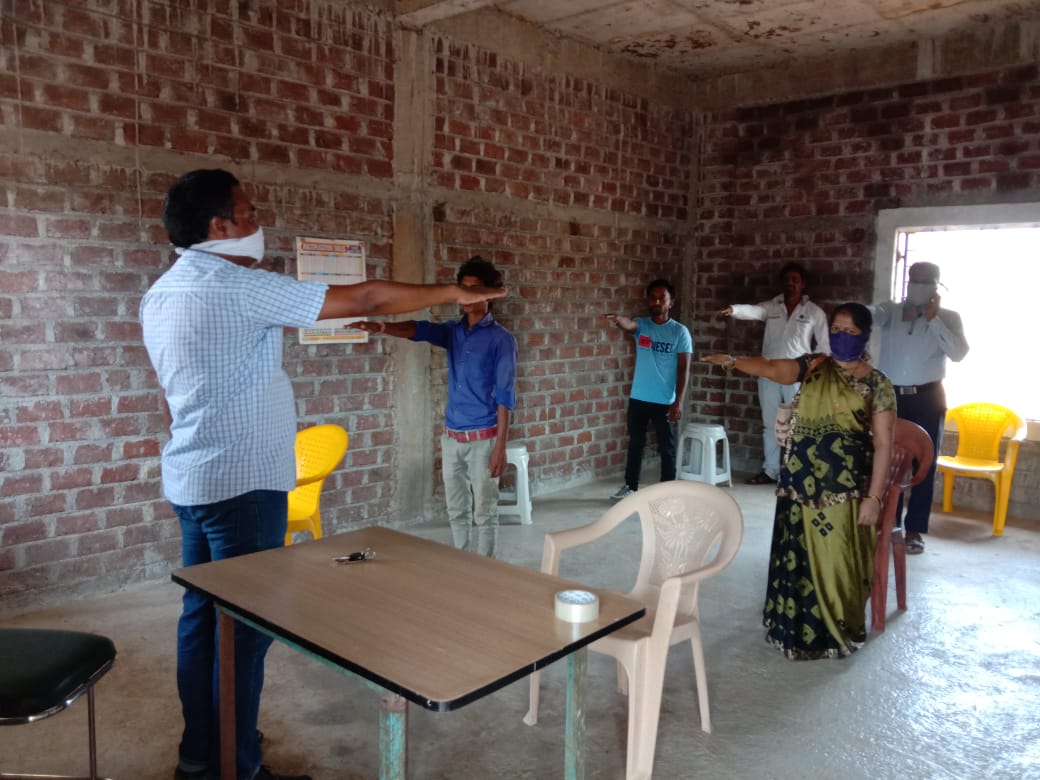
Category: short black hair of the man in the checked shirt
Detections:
[{"x1": 162, "y1": 168, "x2": 238, "y2": 246}]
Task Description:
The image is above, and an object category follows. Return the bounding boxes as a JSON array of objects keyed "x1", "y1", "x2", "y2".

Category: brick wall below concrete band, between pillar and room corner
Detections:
[{"x1": 431, "y1": 209, "x2": 682, "y2": 487}]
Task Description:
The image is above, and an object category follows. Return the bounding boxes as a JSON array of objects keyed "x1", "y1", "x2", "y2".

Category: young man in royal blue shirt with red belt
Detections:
[{"x1": 355, "y1": 256, "x2": 517, "y2": 557}]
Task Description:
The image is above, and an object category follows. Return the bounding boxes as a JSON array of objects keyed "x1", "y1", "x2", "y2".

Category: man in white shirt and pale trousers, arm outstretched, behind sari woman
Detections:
[{"x1": 719, "y1": 263, "x2": 831, "y2": 485}]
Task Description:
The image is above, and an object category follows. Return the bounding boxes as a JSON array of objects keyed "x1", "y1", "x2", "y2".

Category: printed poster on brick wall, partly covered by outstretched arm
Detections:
[{"x1": 296, "y1": 236, "x2": 368, "y2": 344}]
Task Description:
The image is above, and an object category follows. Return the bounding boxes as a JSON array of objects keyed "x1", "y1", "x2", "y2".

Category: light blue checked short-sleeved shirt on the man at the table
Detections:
[{"x1": 140, "y1": 250, "x2": 328, "y2": 506}]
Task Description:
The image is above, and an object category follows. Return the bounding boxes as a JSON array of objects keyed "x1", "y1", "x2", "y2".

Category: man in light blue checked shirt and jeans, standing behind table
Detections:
[{"x1": 140, "y1": 170, "x2": 504, "y2": 780}]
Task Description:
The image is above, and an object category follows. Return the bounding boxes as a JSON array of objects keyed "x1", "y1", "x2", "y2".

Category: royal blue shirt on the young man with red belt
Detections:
[{"x1": 412, "y1": 313, "x2": 517, "y2": 431}]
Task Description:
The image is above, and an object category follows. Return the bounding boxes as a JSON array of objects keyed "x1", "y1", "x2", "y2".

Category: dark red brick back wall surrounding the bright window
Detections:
[{"x1": 693, "y1": 66, "x2": 1040, "y2": 470}]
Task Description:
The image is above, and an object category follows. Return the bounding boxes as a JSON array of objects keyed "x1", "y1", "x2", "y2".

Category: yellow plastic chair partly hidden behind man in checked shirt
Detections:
[{"x1": 285, "y1": 425, "x2": 349, "y2": 547}]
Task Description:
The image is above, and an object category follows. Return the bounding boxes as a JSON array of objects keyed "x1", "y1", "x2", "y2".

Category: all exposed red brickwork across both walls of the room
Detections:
[{"x1": 6, "y1": 0, "x2": 1040, "y2": 607}]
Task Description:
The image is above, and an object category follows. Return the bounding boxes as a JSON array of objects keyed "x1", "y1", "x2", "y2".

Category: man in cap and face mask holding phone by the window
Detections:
[{"x1": 870, "y1": 263, "x2": 968, "y2": 554}]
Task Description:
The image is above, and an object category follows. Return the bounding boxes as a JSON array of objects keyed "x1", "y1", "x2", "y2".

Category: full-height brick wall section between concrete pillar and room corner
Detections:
[{"x1": 432, "y1": 37, "x2": 692, "y2": 486}]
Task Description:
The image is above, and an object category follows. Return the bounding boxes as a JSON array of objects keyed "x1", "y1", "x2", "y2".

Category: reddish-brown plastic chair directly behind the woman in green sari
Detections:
[{"x1": 870, "y1": 419, "x2": 935, "y2": 631}]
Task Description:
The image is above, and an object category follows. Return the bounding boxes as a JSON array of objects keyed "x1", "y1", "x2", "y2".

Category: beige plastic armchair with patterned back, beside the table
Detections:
[{"x1": 524, "y1": 482, "x2": 744, "y2": 780}]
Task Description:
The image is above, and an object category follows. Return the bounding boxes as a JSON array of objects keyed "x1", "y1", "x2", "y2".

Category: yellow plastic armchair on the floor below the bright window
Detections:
[{"x1": 936, "y1": 404, "x2": 1025, "y2": 537}]
